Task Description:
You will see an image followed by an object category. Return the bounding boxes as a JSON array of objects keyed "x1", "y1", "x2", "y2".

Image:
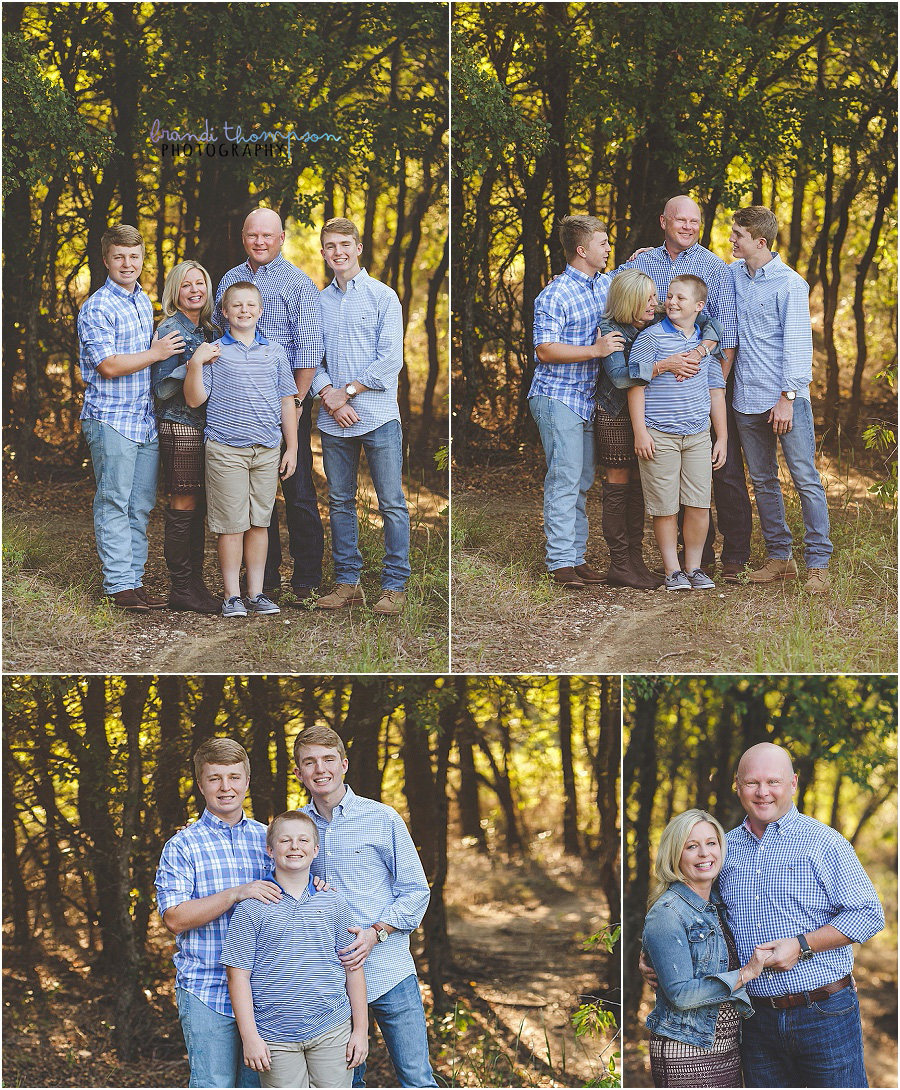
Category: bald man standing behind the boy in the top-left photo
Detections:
[{"x1": 215, "y1": 208, "x2": 325, "y2": 605}]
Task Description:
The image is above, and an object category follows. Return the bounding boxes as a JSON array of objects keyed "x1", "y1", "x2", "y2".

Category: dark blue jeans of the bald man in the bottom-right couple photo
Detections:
[{"x1": 741, "y1": 986, "x2": 868, "y2": 1087}]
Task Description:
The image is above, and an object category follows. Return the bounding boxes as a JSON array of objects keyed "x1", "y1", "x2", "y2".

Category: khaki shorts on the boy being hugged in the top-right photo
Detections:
[{"x1": 637, "y1": 427, "x2": 713, "y2": 516}]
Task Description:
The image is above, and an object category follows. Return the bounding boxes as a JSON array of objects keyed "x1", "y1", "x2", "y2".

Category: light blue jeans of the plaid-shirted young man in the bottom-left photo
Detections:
[{"x1": 175, "y1": 988, "x2": 259, "y2": 1087}]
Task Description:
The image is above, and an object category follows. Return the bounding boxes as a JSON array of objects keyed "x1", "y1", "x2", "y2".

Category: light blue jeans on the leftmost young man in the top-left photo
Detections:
[{"x1": 82, "y1": 420, "x2": 159, "y2": 594}]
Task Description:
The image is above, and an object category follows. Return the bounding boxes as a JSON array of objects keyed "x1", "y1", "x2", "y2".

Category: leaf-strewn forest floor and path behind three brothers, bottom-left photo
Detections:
[{"x1": 2, "y1": 849, "x2": 609, "y2": 1087}]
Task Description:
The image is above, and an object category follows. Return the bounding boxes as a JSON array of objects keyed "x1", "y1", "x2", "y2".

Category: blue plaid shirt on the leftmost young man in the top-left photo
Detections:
[{"x1": 77, "y1": 277, "x2": 157, "y2": 443}]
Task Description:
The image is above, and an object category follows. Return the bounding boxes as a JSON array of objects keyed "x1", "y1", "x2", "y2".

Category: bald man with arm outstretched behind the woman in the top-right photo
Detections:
[{"x1": 612, "y1": 194, "x2": 753, "y2": 583}]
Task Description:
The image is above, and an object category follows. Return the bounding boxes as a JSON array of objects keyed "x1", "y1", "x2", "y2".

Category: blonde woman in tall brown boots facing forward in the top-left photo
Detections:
[{"x1": 150, "y1": 261, "x2": 221, "y2": 614}]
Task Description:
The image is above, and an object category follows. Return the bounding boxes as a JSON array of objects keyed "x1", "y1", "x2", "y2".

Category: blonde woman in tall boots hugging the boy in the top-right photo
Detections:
[{"x1": 594, "y1": 269, "x2": 720, "y2": 590}]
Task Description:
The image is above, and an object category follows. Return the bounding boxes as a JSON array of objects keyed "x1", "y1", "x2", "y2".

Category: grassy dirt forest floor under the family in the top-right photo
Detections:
[{"x1": 451, "y1": 442, "x2": 897, "y2": 674}]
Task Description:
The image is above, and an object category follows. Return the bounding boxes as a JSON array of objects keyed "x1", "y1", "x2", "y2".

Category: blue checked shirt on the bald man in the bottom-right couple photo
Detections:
[{"x1": 719, "y1": 807, "x2": 885, "y2": 995}]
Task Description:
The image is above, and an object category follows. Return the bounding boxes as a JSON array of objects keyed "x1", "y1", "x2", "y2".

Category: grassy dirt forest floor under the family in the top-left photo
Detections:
[{"x1": 3, "y1": 425, "x2": 448, "y2": 674}]
